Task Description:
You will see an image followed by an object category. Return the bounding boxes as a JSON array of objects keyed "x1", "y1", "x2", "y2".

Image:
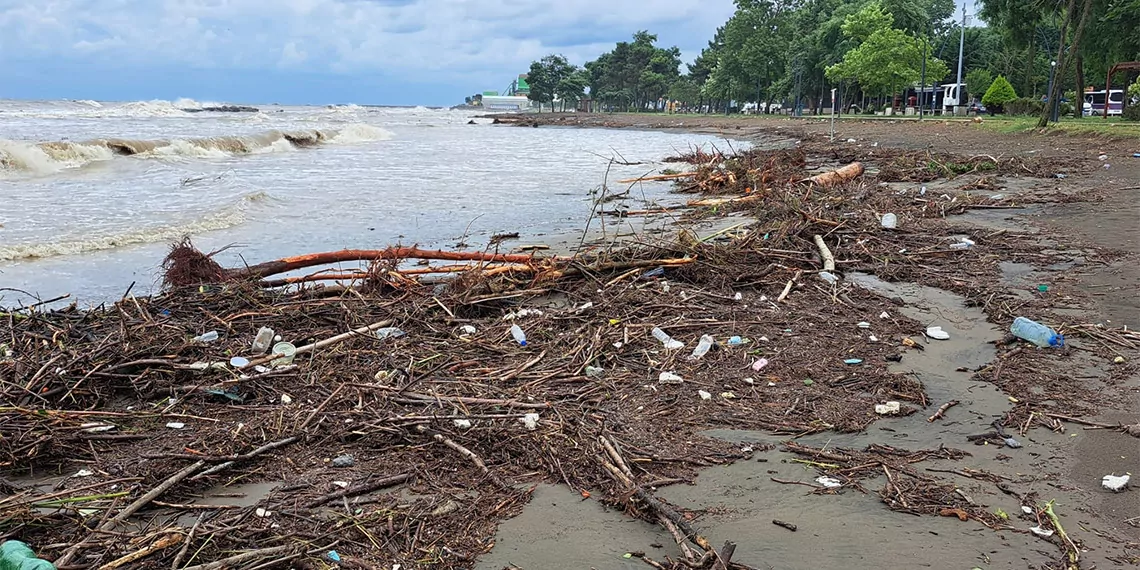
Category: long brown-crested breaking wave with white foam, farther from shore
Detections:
[{"x1": 0, "y1": 123, "x2": 392, "y2": 174}]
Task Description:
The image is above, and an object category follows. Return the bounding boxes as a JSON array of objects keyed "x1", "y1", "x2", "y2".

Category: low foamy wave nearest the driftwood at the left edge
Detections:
[{"x1": 0, "y1": 192, "x2": 271, "y2": 261}]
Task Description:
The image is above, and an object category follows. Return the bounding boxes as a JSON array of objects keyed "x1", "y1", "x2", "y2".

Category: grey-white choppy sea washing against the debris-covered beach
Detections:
[{"x1": 0, "y1": 99, "x2": 728, "y2": 307}]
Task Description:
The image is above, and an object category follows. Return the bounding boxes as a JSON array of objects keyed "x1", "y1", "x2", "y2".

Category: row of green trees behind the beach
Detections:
[{"x1": 528, "y1": 0, "x2": 1140, "y2": 125}]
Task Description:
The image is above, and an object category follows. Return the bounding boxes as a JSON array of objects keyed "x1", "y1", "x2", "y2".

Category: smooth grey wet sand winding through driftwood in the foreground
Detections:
[{"x1": 479, "y1": 274, "x2": 1119, "y2": 570}]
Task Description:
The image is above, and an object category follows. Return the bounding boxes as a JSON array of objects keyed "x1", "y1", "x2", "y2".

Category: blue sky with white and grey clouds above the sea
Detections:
[{"x1": 0, "y1": 0, "x2": 733, "y2": 105}]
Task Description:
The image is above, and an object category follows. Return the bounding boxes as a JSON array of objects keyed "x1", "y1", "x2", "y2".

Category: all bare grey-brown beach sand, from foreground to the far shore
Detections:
[{"x1": 478, "y1": 115, "x2": 1140, "y2": 570}]
